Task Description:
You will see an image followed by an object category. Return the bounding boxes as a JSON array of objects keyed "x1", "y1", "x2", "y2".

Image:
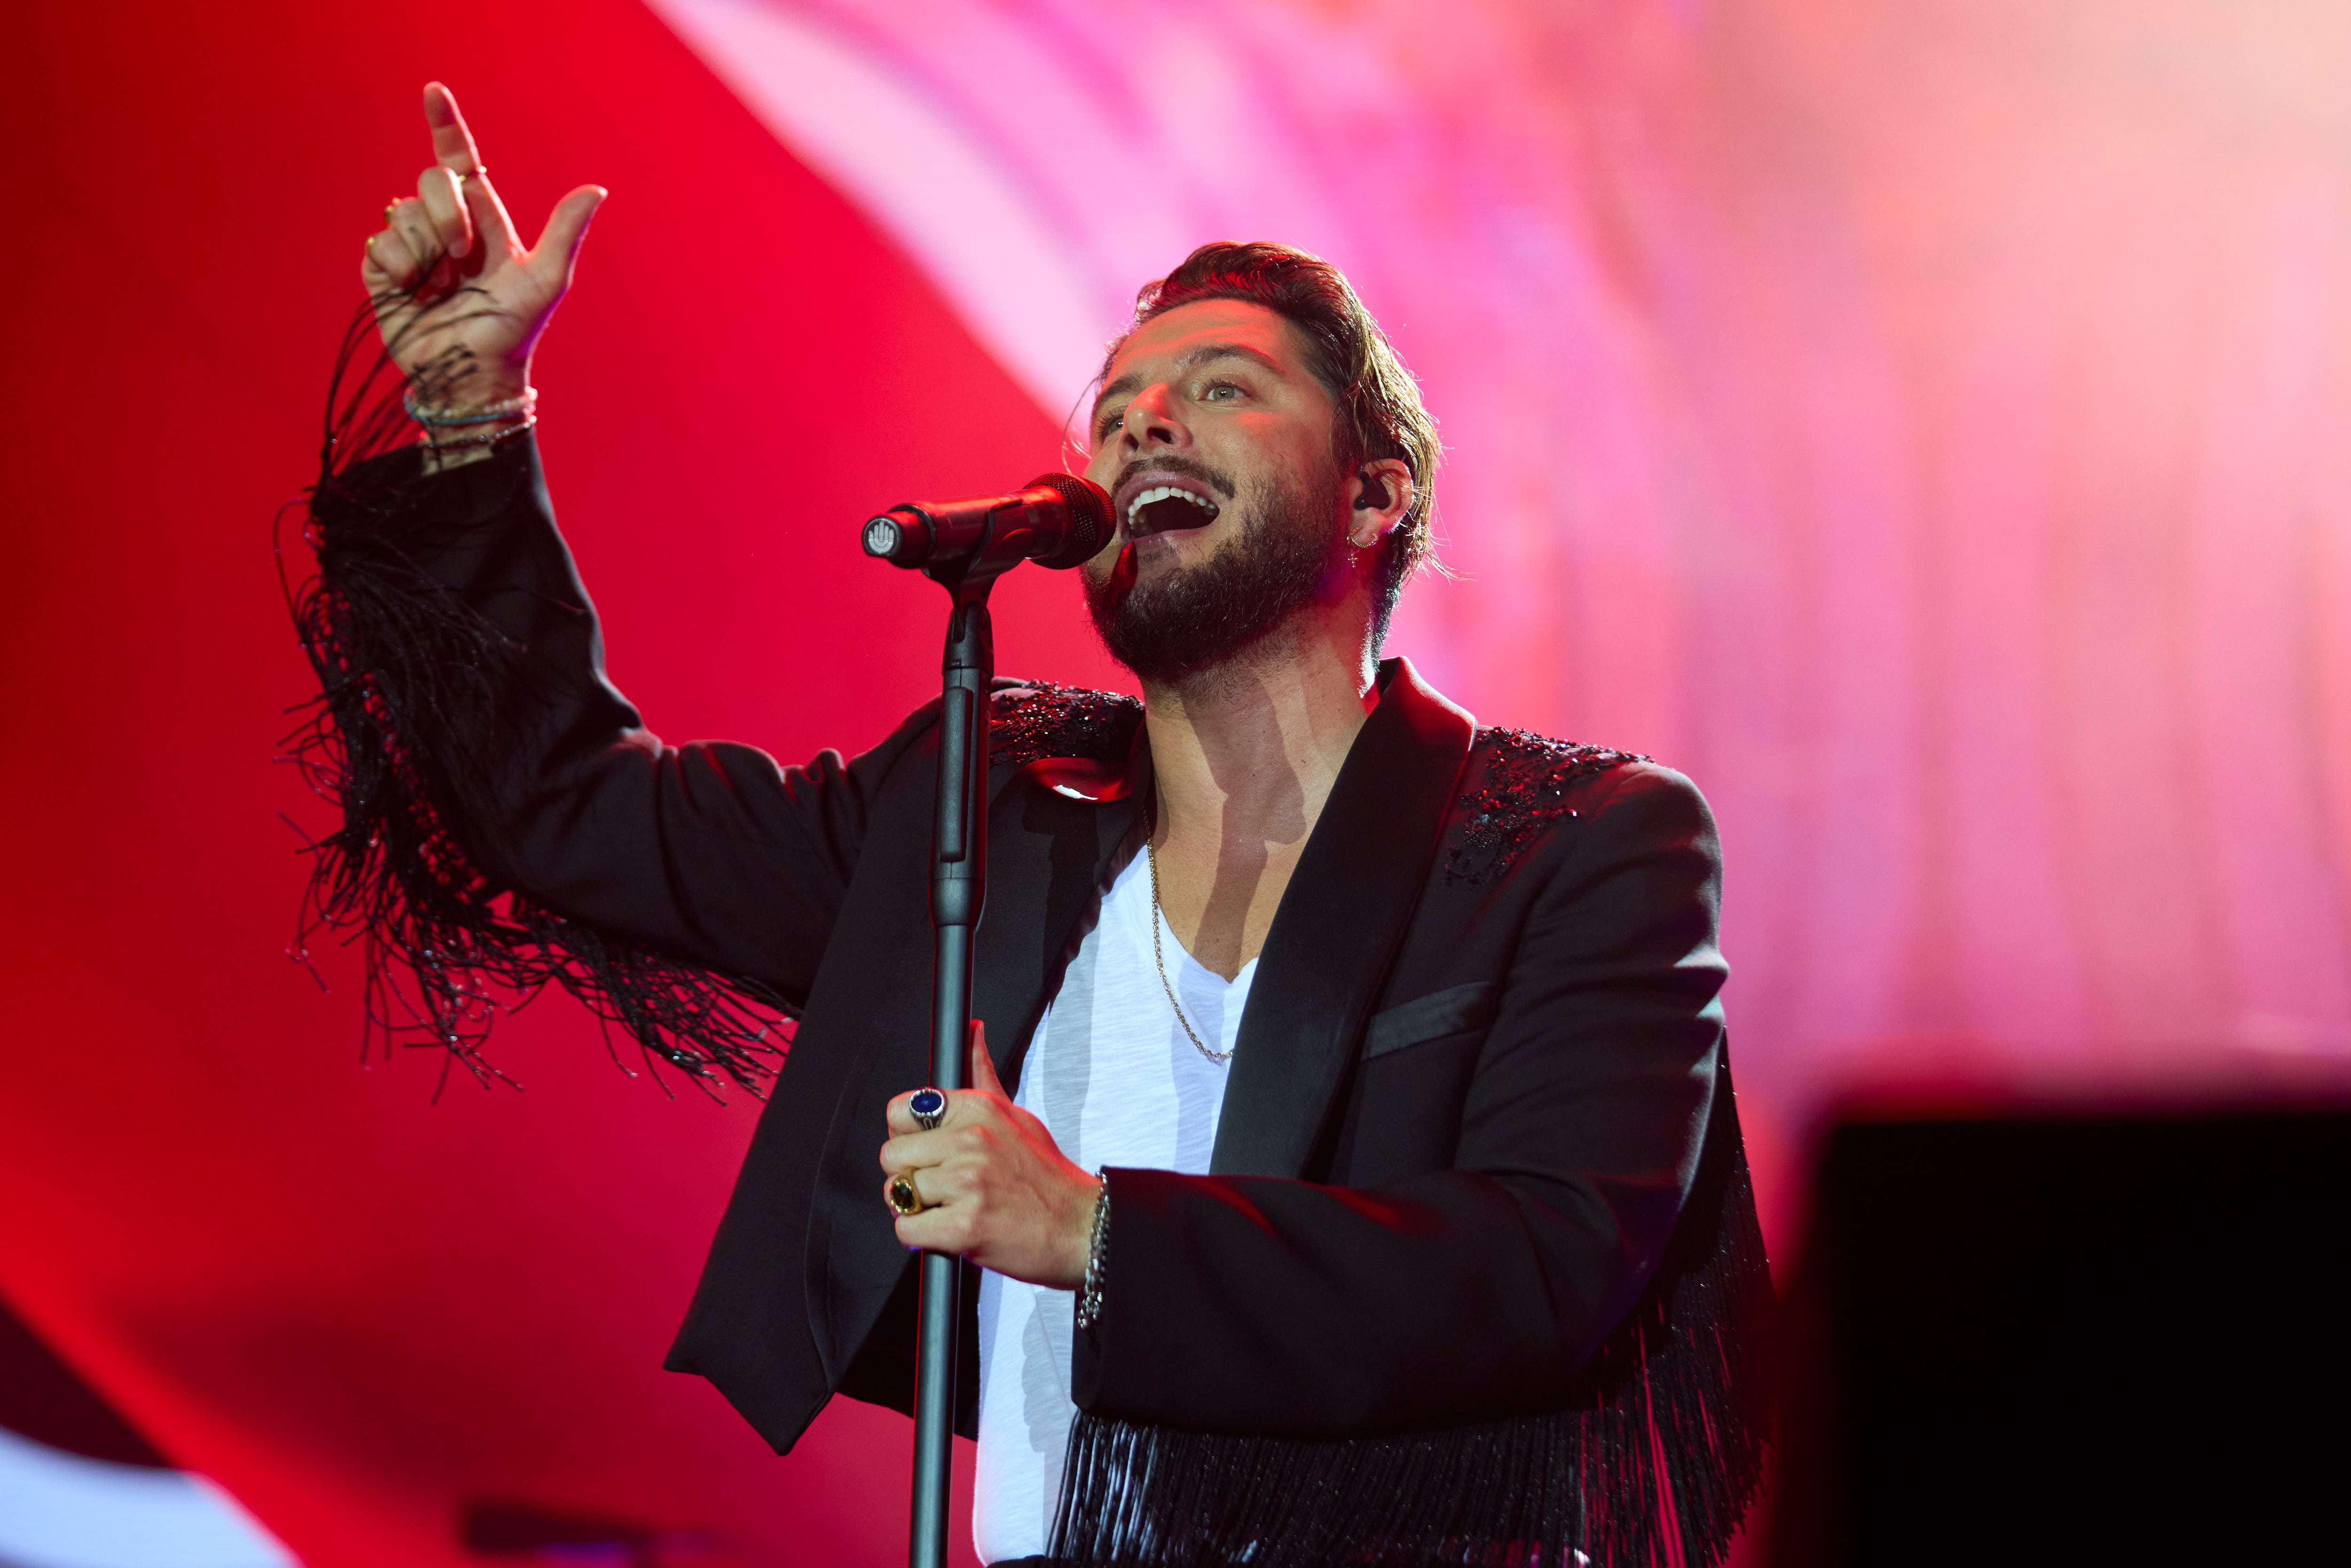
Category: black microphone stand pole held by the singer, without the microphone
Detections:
[{"x1": 907, "y1": 550, "x2": 1002, "y2": 1568}]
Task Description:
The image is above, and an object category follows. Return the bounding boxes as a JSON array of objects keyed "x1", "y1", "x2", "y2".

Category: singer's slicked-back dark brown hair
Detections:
[{"x1": 1103, "y1": 240, "x2": 1439, "y2": 646}]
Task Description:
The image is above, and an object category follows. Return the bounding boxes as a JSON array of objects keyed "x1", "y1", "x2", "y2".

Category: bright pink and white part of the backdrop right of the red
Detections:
[{"x1": 654, "y1": 0, "x2": 2351, "y2": 1126}]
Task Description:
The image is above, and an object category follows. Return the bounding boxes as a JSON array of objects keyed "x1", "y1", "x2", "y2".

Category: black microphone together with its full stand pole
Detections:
[{"x1": 863, "y1": 475, "x2": 1110, "y2": 1568}]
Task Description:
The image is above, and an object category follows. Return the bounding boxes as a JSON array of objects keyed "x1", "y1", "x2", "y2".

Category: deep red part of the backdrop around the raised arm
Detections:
[{"x1": 0, "y1": 0, "x2": 1117, "y2": 1568}]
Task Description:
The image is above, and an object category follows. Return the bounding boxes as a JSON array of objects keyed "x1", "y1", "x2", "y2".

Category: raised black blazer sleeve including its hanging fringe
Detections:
[{"x1": 287, "y1": 303, "x2": 889, "y2": 1093}]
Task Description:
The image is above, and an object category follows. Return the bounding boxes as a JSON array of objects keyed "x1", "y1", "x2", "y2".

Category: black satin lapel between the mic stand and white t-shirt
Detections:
[{"x1": 971, "y1": 724, "x2": 1150, "y2": 1091}]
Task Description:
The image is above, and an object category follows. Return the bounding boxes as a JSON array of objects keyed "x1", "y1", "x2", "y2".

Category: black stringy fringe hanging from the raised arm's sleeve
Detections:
[{"x1": 277, "y1": 288, "x2": 795, "y2": 1095}]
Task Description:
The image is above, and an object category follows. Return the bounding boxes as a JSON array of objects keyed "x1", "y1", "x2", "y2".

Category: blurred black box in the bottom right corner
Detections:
[{"x1": 1768, "y1": 1110, "x2": 2351, "y2": 1568}]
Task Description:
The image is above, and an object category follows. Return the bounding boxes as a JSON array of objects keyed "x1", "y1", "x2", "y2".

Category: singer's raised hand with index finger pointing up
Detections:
[{"x1": 360, "y1": 82, "x2": 604, "y2": 409}]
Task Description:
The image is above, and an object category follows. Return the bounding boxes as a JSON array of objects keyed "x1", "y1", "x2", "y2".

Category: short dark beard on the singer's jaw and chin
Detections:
[{"x1": 1086, "y1": 463, "x2": 1342, "y2": 686}]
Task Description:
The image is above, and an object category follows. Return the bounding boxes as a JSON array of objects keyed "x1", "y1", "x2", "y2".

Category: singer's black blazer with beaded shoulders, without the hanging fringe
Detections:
[{"x1": 299, "y1": 440, "x2": 1761, "y2": 1568}]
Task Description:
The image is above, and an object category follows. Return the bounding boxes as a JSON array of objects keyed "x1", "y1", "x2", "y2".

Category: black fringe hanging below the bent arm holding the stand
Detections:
[{"x1": 1049, "y1": 1079, "x2": 1773, "y2": 1568}]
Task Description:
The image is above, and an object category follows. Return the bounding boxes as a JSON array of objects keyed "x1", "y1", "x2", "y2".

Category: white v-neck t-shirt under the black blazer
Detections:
[{"x1": 971, "y1": 856, "x2": 1258, "y2": 1563}]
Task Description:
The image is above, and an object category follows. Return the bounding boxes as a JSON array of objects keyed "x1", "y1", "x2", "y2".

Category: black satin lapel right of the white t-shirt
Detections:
[{"x1": 1211, "y1": 658, "x2": 1476, "y2": 1175}]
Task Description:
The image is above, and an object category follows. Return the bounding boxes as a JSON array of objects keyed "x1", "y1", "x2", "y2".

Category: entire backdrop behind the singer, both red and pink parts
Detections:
[{"x1": 0, "y1": 0, "x2": 2351, "y2": 1568}]
